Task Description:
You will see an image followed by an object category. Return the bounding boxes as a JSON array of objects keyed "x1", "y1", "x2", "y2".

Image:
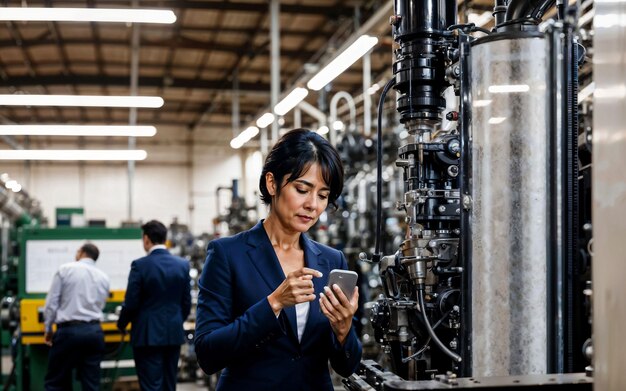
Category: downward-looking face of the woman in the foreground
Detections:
[{"x1": 266, "y1": 163, "x2": 330, "y2": 232}]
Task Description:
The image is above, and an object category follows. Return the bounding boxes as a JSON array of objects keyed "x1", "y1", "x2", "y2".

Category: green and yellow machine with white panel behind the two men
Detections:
[{"x1": 3, "y1": 226, "x2": 145, "y2": 391}]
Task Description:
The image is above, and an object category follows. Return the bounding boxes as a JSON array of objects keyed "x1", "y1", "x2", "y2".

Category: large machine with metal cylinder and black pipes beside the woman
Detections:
[{"x1": 345, "y1": 0, "x2": 591, "y2": 390}]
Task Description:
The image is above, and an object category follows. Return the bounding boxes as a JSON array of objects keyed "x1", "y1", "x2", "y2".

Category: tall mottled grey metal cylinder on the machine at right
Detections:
[{"x1": 470, "y1": 33, "x2": 550, "y2": 376}]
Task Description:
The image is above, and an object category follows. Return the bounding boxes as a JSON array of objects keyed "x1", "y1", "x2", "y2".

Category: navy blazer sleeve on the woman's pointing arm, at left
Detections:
[{"x1": 195, "y1": 241, "x2": 282, "y2": 374}]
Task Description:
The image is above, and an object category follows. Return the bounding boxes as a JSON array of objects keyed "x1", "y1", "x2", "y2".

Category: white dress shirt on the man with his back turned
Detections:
[{"x1": 44, "y1": 258, "x2": 109, "y2": 332}]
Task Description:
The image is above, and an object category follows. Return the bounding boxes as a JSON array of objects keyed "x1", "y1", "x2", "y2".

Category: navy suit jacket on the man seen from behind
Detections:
[{"x1": 117, "y1": 249, "x2": 191, "y2": 347}]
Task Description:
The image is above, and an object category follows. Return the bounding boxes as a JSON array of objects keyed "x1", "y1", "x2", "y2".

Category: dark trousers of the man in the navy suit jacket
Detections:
[{"x1": 133, "y1": 345, "x2": 180, "y2": 391}]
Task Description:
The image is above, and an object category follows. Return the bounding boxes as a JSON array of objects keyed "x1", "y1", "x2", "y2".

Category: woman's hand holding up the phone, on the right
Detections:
[{"x1": 320, "y1": 284, "x2": 359, "y2": 345}]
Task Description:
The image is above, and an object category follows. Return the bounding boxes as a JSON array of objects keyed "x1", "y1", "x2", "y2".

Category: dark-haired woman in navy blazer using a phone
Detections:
[{"x1": 195, "y1": 129, "x2": 361, "y2": 391}]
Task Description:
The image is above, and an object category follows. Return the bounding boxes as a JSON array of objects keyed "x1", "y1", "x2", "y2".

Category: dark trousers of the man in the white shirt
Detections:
[{"x1": 45, "y1": 323, "x2": 104, "y2": 391}]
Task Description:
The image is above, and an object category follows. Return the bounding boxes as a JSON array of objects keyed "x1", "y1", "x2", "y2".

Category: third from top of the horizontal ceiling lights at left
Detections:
[{"x1": 0, "y1": 125, "x2": 156, "y2": 137}]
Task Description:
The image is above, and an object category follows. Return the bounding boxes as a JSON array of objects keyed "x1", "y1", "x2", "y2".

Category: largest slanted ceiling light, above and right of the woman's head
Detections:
[{"x1": 307, "y1": 35, "x2": 378, "y2": 91}]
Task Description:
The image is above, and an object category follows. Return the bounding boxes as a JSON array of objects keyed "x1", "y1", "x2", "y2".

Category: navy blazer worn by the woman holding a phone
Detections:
[{"x1": 195, "y1": 223, "x2": 361, "y2": 391}]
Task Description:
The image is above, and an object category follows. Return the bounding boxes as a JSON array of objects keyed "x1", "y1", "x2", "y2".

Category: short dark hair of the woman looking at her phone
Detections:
[{"x1": 259, "y1": 129, "x2": 343, "y2": 208}]
